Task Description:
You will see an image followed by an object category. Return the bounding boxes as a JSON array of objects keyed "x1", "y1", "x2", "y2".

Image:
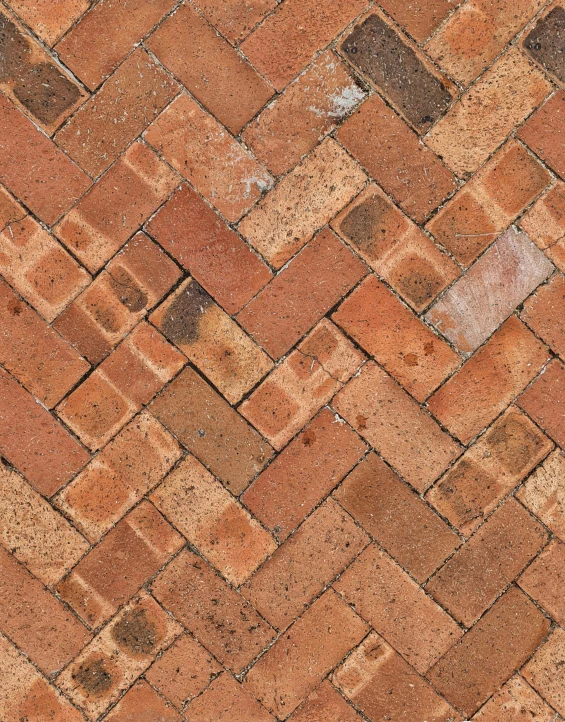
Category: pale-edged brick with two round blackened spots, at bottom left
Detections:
[{"x1": 57, "y1": 592, "x2": 181, "y2": 722}]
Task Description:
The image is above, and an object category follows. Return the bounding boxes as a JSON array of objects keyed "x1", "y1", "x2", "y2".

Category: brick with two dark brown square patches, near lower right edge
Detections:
[{"x1": 426, "y1": 407, "x2": 552, "y2": 536}]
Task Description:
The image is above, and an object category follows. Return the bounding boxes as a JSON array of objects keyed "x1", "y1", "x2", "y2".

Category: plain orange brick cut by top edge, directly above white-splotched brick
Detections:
[{"x1": 241, "y1": 0, "x2": 367, "y2": 91}]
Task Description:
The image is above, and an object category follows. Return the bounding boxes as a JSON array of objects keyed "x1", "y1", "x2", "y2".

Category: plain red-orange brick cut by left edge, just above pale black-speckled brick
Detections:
[{"x1": 0, "y1": 369, "x2": 89, "y2": 496}]
